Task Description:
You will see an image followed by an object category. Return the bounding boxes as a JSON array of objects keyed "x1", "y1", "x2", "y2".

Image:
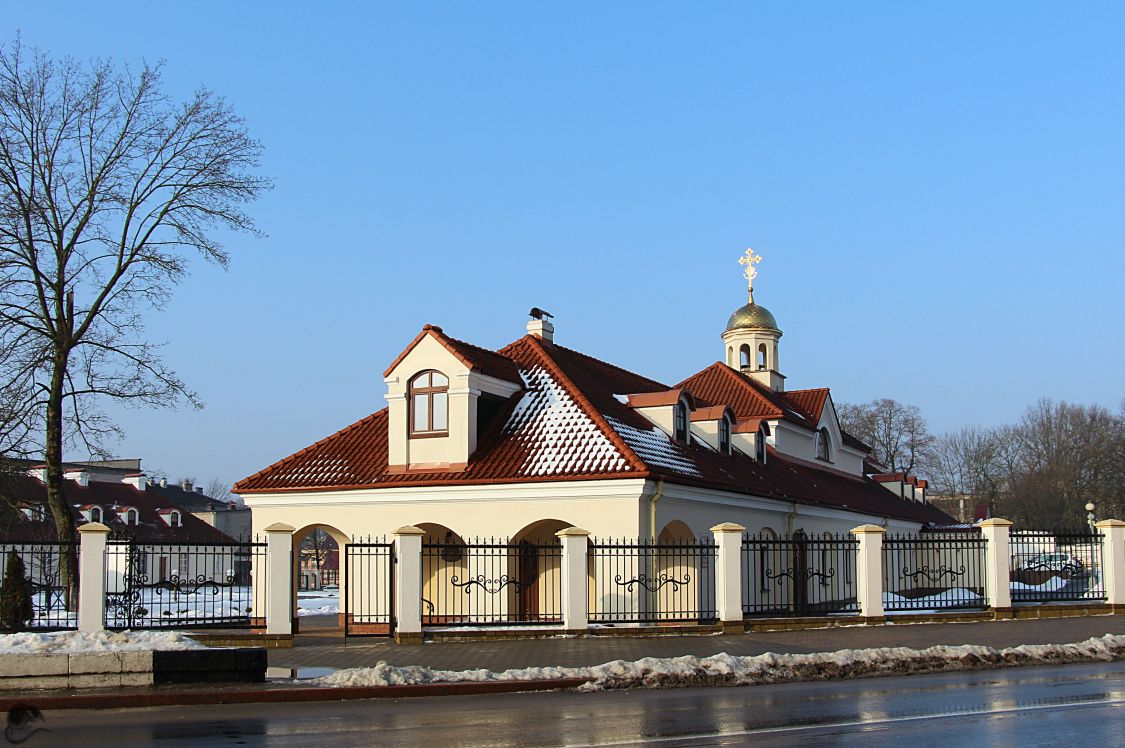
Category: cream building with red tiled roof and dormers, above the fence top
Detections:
[{"x1": 234, "y1": 262, "x2": 952, "y2": 543}]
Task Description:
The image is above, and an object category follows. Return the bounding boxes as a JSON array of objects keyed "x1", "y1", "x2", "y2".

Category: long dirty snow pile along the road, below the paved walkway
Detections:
[{"x1": 312, "y1": 634, "x2": 1125, "y2": 691}]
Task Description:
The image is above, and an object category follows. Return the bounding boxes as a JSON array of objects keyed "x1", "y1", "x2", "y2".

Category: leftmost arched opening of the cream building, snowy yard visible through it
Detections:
[{"x1": 290, "y1": 524, "x2": 346, "y2": 632}]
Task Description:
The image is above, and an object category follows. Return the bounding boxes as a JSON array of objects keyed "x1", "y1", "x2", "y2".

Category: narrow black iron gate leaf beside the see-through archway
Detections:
[{"x1": 343, "y1": 538, "x2": 395, "y2": 637}]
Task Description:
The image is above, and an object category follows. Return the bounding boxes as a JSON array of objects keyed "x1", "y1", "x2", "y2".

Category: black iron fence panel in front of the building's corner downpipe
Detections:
[{"x1": 587, "y1": 538, "x2": 719, "y2": 623}]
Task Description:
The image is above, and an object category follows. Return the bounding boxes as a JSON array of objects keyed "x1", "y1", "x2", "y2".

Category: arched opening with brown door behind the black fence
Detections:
[{"x1": 507, "y1": 519, "x2": 574, "y2": 623}]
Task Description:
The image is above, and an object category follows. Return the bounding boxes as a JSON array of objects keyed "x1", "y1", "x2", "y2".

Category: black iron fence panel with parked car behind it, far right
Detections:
[{"x1": 1009, "y1": 530, "x2": 1106, "y2": 603}]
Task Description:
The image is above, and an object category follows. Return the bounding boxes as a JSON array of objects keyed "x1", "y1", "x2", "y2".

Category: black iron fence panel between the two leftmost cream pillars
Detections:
[{"x1": 105, "y1": 538, "x2": 267, "y2": 629}]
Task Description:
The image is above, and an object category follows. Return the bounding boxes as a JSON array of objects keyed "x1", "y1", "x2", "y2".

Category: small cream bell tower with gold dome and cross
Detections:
[{"x1": 722, "y1": 250, "x2": 785, "y2": 391}]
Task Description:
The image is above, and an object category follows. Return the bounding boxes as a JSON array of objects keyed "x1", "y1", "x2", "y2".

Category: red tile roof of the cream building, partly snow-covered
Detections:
[{"x1": 235, "y1": 328, "x2": 951, "y2": 523}]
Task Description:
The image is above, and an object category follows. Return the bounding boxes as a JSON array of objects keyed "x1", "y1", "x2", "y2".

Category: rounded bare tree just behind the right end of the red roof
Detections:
[{"x1": 837, "y1": 398, "x2": 934, "y2": 472}]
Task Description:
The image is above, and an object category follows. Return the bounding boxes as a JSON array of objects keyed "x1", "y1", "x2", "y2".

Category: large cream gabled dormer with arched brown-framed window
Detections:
[{"x1": 384, "y1": 325, "x2": 523, "y2": 471}]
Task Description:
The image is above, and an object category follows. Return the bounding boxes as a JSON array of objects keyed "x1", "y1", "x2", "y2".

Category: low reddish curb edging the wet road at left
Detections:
[{"x1": 0, "y1": 678, "x2": 587, "y2": 712}]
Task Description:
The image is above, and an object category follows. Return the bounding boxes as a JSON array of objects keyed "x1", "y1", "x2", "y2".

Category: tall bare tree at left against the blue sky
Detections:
[{"x1": 0, "y1": 38, "x2": 268, "y2": 602}]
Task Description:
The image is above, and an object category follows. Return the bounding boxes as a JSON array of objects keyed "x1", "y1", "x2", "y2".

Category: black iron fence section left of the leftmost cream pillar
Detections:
[{"x1": 0, "y1": 540, "x2": 78, "y2": 631}]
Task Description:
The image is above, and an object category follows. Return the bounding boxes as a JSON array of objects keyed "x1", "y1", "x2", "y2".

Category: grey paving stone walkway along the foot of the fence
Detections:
[{"x1": 269, "y1": 615, "x2": 1125, "y2": 670}]
